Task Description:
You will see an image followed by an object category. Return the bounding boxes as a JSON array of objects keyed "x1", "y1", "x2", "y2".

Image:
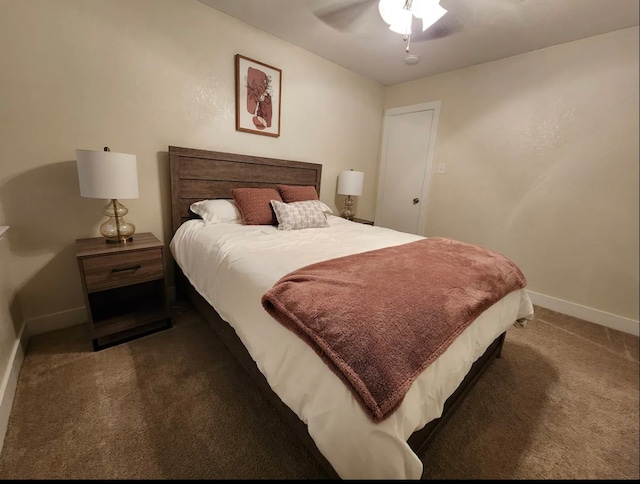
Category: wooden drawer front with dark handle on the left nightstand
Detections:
[{"x1": 82, "y1": 249, "x2": 164, "y2": 292}]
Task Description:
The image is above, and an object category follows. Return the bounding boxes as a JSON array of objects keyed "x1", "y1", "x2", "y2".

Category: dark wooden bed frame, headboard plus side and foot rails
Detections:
[{"x1": 169, "y1": 146, "x2": 506, "y2": 479}]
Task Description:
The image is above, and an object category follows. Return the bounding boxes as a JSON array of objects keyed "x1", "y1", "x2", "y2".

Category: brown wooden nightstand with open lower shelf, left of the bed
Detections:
[{"x1": 76, "y1": 233, "x2": 171, "y2": 351}]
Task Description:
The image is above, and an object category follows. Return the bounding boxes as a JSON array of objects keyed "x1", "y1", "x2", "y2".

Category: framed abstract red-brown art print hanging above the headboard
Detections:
[{"x1": 235, "y1": 54, "x2": 282, "y2": 138}]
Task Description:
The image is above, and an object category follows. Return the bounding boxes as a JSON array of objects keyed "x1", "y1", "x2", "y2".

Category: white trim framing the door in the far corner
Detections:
[{"x1": 376, "y1": 101, "x2": 442, "y2": 235}]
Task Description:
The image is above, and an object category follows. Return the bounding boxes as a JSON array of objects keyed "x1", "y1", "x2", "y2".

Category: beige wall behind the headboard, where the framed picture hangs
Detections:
[{"x1": 0, "y1": 0, "x2": 383, "y2": 328}]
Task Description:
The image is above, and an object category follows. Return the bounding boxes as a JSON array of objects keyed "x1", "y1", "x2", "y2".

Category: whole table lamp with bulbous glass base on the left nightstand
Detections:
[{"x1": 76, "y1": 147, "x2": 138, "y2": 244}]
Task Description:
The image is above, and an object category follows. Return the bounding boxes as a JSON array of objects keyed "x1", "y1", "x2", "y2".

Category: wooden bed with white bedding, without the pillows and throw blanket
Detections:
[{"x1": 169, "y1": 146, "x2": 533, "y2": 479}]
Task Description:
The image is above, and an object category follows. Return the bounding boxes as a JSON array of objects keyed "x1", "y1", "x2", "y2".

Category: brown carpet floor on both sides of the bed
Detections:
[{"x1": 0, "y1": 306, "x2": 640, "y2": 479}]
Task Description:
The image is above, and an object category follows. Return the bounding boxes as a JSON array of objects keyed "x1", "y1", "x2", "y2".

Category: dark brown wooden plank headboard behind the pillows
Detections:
[{"x1": 169, "y1": 146, "x2": 322, "y2": 234}]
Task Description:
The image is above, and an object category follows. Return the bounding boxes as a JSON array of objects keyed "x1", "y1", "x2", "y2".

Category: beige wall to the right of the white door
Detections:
[{"x1": 384, "y1": 27, "x2": 639, "y2": 321}]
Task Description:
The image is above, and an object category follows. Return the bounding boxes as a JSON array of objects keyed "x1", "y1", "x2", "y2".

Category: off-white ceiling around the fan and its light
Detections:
[{"x1": 199, "y1": 0, "x2": 640, "y2": 85}]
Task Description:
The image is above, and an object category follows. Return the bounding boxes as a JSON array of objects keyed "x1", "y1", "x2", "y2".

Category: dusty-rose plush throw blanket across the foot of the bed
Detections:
[{"x1": 262, "y1": 237, "x2": 526, "y2": 422}]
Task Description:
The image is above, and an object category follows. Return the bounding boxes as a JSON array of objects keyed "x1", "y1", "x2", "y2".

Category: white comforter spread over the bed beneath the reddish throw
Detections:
[{"x1": 170, "y1": 215, "x2": 533, "y2": 479}]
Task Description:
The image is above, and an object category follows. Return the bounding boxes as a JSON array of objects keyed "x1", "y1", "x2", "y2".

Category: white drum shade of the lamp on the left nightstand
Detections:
[{"x1": 76, "y1": 150, "x2": 138, "y2": 199}]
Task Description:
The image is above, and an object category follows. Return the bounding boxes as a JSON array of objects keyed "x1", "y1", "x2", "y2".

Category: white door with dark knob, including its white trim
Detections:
[{"x1": 375, "y1": 101, "x2": 440, "y2": 235}]
